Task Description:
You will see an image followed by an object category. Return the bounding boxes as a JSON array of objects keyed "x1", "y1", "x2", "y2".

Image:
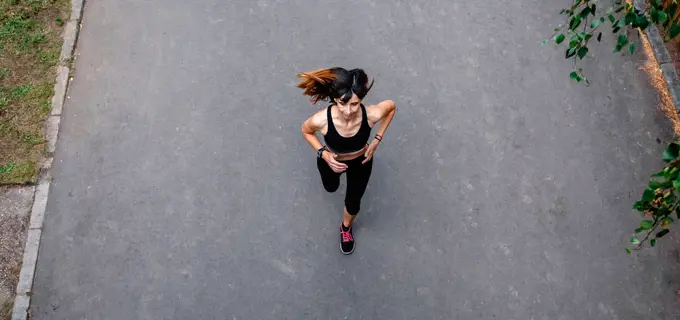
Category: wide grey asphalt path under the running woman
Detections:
[{"x1": 32, "y1": 0, "x2": 680, "y2": 320}]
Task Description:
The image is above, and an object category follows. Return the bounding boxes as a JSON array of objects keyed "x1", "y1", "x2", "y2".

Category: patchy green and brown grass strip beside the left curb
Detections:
[{"x1": 0, "y1": 0, "x2": 70, "y2": 184}]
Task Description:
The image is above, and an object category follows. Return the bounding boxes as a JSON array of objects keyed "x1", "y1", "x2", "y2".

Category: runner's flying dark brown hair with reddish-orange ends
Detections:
[{"x1": 297, "y1": 68, "x2": 373, "y2": 104}]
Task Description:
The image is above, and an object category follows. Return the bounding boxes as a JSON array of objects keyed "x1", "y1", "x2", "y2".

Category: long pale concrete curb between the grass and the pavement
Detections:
[{"x1": 12, "y1": 0, "x2": 84, "y2": 320}]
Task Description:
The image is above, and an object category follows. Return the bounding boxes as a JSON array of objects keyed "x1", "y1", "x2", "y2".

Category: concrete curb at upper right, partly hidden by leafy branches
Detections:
[{"x1": 634, "y1": 0, "x2": 680, "y2": 112}]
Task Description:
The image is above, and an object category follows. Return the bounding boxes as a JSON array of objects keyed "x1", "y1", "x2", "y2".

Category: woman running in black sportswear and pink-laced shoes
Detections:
[{"x1": 298, "y1": 68, "x2": 396, "y2": 254}]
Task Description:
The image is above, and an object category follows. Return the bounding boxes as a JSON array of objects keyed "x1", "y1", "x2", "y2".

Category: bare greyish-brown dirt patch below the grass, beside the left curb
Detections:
[{"x1": 0, "y1": 186, "x2": 35, "y2": 320}]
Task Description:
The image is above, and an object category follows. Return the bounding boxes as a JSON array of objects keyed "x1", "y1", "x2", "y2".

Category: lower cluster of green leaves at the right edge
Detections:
[{"x1": 626, "y1": 142, "x2": 680, "y2": 253}]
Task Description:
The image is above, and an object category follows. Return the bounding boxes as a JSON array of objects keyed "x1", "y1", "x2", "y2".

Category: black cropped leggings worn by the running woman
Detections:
[{"x1": 316, "y1": 156, "x2": 373, "y2": 216}]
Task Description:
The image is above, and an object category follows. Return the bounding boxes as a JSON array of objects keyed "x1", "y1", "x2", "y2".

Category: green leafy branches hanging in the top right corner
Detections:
[{"x1": 544, "y1": 0, "x2": 680, "y2": 84}]
